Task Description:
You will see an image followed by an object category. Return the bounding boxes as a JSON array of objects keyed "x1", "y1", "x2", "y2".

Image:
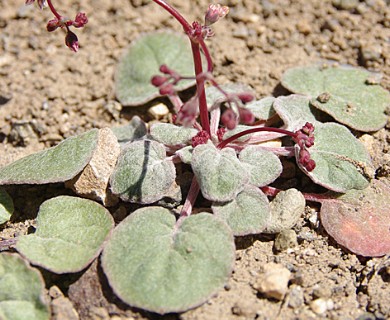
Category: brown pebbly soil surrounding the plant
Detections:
[{"x1": 0, "y1": 0, "x2": 390, "y2": 320}]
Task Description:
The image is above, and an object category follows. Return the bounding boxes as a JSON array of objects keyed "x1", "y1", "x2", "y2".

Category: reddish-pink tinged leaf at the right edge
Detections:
[{"x1": 321, "y1": 180, "x2": 390, "y2": 257}]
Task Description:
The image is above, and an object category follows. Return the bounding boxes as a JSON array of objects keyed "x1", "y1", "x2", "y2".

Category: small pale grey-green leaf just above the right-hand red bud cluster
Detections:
[{"x1": 273, "y1": 94, "x2": 318, "y2": 132}]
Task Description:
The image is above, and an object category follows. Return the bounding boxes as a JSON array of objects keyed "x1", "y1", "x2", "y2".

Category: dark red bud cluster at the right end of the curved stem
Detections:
[{"x1": 293, "y1": 122, "x2": 316, "y2": 171}]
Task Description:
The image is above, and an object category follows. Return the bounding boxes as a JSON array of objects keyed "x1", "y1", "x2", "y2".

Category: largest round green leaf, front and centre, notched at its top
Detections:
[{"x1": 102, "y1": 207, "x2": 235, "y2": 314}]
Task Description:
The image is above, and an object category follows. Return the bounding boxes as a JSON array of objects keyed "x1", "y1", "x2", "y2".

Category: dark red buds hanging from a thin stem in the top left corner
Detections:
[{"x1": 26, "y1": 0, "x2": 88, "y2": 52}]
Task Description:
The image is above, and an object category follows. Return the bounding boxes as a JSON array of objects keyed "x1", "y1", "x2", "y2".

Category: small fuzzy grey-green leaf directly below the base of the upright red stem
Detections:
[{"x1": 191, "y1": 144, "x2": 249, "y2": 202}]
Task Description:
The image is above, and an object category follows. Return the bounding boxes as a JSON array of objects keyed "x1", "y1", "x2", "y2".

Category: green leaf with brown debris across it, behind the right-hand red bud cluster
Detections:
[{"x1": 296, "y1": 123, "x2": 374, "y2": 192}]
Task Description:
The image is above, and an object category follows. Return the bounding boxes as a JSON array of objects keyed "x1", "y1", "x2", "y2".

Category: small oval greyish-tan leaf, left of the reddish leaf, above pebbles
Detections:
[{"x1": 265, "y1": 189, "x2": 306, "y2": 233}]
